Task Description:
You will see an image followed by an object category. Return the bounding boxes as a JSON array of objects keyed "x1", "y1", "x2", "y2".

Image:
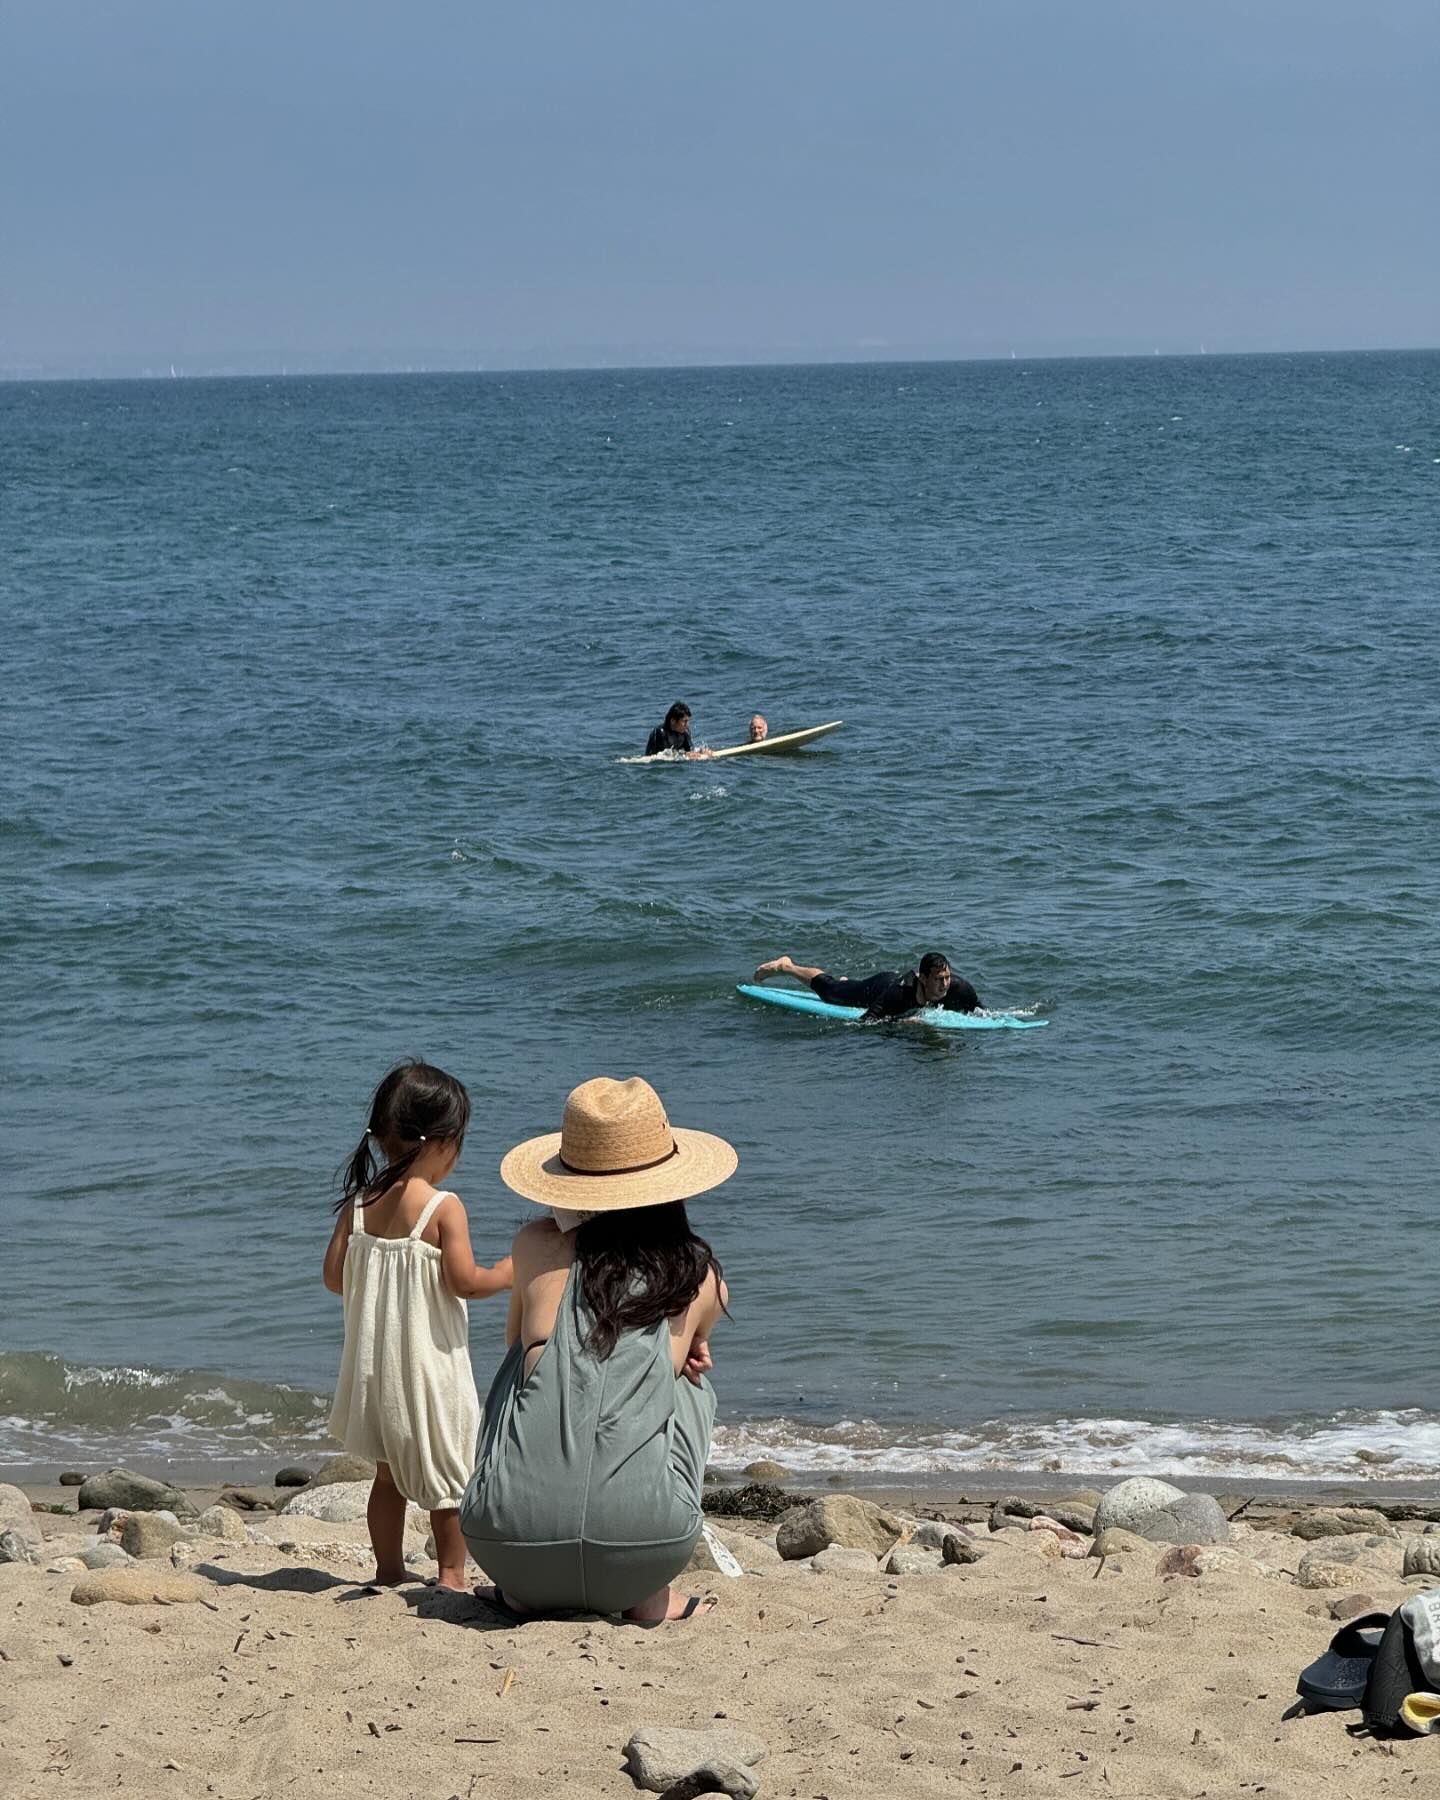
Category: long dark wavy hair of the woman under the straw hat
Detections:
[{"x1": 574, "y1": 1201, "x2": 724, "y2": 1359}]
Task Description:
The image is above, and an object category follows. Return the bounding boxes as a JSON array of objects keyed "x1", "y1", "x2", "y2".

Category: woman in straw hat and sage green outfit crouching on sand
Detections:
[{"x1": 461, "y1": 1076, "x2": 736, "y2": 1624}]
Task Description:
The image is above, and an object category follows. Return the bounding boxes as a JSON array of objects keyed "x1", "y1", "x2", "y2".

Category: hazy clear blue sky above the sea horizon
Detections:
[{"x1": 0, "y1": 0, "x2": 1440, "y2": 373}]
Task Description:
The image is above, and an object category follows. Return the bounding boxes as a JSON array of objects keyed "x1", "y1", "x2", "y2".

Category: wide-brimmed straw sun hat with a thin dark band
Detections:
[{"x1": 500, "y1": 1075, "x2": 740, "y2": 1213}]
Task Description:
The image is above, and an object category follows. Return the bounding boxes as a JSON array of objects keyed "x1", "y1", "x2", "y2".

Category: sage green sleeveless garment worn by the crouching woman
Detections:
[{"x1": 461, "y1": 1269, "x2": 715, "y2": 1613}]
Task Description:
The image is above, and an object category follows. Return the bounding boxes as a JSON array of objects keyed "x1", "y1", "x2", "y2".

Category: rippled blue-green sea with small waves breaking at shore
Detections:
[{"x1": 0, "y1": 355, "x2": 1440, "y2": 1472}]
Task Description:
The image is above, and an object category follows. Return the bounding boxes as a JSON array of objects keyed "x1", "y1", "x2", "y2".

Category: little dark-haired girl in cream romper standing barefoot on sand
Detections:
[{"x1": 324, "y1": 1062, "x2": 511, "y2": 1589}]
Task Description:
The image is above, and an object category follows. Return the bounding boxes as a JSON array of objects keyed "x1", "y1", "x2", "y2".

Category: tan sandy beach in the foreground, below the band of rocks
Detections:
[{"x1": 0, "y1": 1490, "x2": 1440, "y2": 1800}]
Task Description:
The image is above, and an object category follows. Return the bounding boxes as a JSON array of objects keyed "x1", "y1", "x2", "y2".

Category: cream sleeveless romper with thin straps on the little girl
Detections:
[{"x1": 329, "y1": 1193, "x2": 481, "y2": 1512}]
